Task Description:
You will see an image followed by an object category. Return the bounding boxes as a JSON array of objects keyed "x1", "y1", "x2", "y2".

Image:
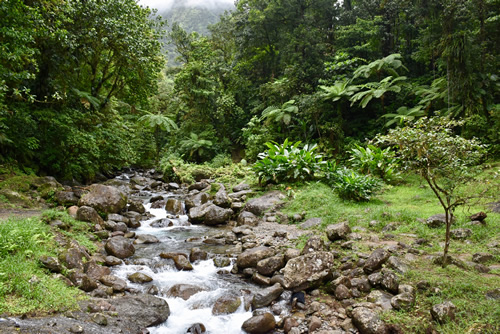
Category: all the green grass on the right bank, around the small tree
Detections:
[{"x1": 282, "y1": 166, "x2": 500, "y2": 334}]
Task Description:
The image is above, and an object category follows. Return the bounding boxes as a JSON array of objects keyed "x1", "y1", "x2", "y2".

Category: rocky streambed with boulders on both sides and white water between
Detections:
[{"x1": 0, "y1": 171, "x2": 482, "y2": 334}]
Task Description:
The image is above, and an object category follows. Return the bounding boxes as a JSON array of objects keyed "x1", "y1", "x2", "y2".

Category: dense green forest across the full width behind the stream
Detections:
[{"x1": 0, "y1": 0, "x2": 500, "y2": 180}]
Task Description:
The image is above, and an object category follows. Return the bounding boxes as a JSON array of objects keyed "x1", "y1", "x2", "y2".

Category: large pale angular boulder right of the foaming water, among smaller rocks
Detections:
[{"x1": 283, "y1": 252, "x2": 334, "y2": 289}]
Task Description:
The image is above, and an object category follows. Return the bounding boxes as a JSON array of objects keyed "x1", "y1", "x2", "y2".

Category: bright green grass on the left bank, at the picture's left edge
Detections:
[{"x1": 0, "y1": 212, "x2": 91, "y2": 315}]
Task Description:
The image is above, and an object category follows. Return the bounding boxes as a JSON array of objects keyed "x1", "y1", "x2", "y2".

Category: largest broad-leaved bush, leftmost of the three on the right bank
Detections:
[{"x1": 253, "y1": 139, "x2": 326, "y2": 183}]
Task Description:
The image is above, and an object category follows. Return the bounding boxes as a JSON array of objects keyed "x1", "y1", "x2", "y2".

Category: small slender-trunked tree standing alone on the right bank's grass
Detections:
[{"x1": 379, "y1": 117, "x2": 484, "y2": 267}]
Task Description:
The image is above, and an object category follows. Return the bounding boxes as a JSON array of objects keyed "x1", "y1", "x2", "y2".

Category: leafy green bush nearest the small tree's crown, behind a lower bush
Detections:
[{"x1": 349, "y1": 144, "x2": 399, "y2": 181}]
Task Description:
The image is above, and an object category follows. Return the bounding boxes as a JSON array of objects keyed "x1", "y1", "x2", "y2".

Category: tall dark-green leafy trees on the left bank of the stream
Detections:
[{"x1": 0, "y1": 0, "x2": 164, "y2": 178}]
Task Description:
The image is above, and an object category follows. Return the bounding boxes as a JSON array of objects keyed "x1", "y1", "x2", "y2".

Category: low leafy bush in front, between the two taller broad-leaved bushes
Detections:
[{"x1": 328, "y1": 167, "x2": 382, "y2": 202}]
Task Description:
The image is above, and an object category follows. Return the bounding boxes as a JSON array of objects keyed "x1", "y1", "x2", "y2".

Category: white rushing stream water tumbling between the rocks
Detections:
[{"x1": 113, "y1": 185, "x2": 274, "y2": 334}]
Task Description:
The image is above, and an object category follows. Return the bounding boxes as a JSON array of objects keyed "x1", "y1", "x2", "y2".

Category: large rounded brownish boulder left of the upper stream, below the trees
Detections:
[{"x1": 78, "y1": 184, "x2": 127, "y2": 213}]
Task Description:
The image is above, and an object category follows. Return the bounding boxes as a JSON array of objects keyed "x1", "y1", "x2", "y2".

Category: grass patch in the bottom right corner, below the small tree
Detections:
[{"x1": 384, "y1": 260, "x2": 500, "y2": 334}]
